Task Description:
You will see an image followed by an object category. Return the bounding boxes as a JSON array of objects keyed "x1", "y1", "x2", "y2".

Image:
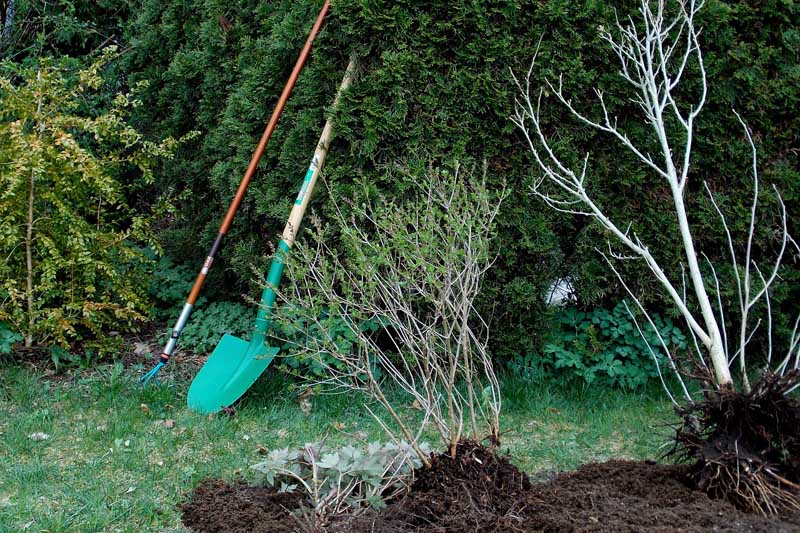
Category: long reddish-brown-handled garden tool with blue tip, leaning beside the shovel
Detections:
[{"x1": 139, "y1": 0, "x2": 330, "y2": 385}]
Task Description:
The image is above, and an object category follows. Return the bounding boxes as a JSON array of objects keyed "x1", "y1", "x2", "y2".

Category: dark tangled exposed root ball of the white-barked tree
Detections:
[{"x1": 673, "y1": 372, "x2": 800, "y2": 514}]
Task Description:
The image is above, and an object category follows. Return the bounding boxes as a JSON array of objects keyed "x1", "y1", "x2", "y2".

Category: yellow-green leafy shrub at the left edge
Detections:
[{"x1": 0, "y1": 47, "x2": 193, "y2": 349}]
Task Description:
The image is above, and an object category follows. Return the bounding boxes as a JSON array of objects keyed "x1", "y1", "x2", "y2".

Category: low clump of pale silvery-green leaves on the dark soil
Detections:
[{"x1": 251, "y1": 441, "x2": 430, "y2": 520}]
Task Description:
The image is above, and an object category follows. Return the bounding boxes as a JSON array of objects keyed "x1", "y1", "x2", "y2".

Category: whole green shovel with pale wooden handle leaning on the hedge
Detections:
[{"x1": 188, "y1": 60, "x2": 355, "y2": 414}]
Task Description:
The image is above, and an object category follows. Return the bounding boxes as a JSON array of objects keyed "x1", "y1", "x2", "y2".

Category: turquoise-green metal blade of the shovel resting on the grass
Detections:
[{"x1": 188, "y1": 334, "x2": 278, "y2": 414}]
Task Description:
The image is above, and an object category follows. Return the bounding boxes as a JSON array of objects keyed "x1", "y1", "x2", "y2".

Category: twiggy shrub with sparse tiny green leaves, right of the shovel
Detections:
[{"x1": 280, "y1": 168, "x2": 506, "y2": 466}]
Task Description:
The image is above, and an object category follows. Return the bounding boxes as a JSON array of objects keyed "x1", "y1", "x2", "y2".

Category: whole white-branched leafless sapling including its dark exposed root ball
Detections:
[{"x1": 513, "y1": 0, "x2": 800, "y2": 513}]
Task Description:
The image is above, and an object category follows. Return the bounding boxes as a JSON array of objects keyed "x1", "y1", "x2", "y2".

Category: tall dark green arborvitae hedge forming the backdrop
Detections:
[{"x1": 125, "y1": 0, "x2": 800, "y2": 355}]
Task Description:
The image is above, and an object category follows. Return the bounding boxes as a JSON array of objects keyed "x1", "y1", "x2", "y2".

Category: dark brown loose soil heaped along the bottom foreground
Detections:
[{"x1": 182, "y1": 443, "x2": 800, "y2": 533}]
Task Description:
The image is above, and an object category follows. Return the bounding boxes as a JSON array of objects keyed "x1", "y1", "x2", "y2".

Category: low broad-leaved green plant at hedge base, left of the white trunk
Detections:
[{"x1": 508, "y1": 301, "x2": 687, "y2": 389}]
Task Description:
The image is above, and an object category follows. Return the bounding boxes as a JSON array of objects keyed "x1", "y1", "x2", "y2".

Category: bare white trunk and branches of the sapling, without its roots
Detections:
[{"x1": 512, "y1": 0, "x2": 764, "y2": 390}]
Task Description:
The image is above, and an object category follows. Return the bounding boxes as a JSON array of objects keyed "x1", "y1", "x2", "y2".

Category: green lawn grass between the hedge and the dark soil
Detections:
[{"x1": 0, "y1": 366, "x2": 674, "y2": 532}]
